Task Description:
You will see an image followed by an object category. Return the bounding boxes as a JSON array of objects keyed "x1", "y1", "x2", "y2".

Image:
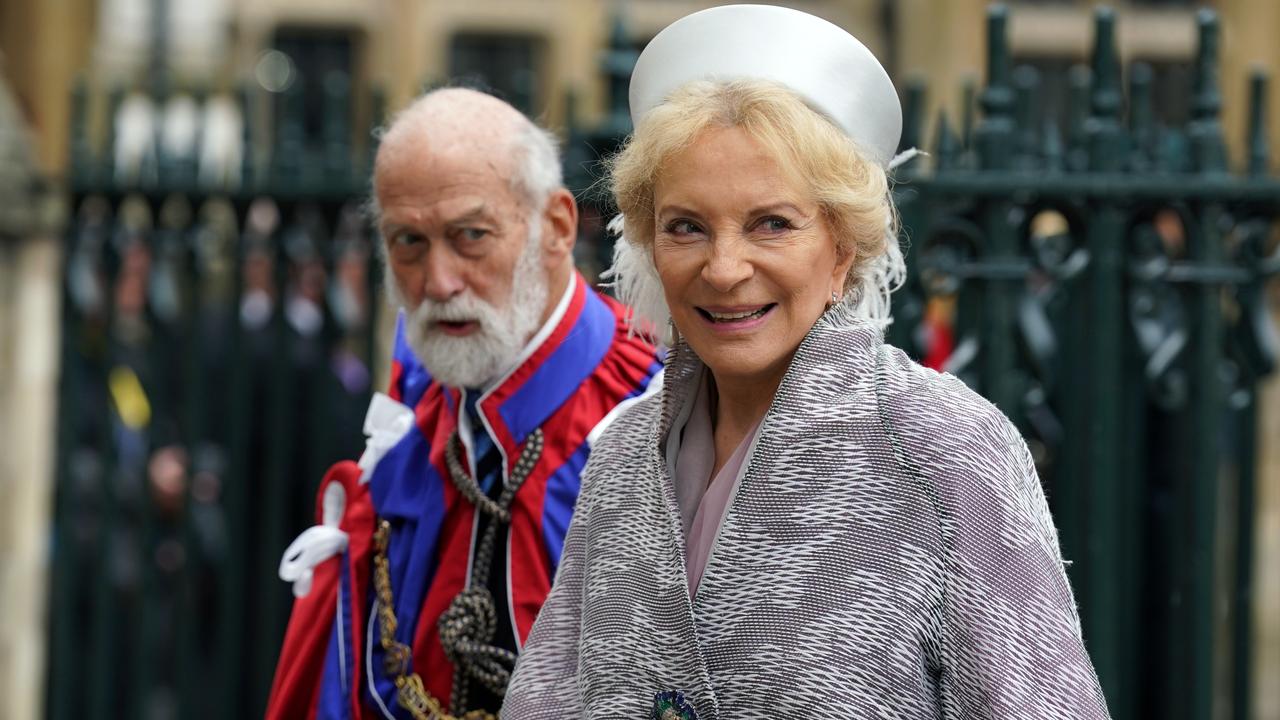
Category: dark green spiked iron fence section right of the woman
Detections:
[{"x1": 891, "y1": 8, "x2": 1280, "y2": 719}]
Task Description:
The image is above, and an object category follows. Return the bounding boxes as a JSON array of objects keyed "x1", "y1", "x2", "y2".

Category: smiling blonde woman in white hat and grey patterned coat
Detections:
[{"x1": 503, "y1": 5, "x2": 1107, "y2": 720}]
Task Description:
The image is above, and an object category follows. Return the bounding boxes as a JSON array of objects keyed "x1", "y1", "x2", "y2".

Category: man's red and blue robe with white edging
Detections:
[{"x1": 259, "y1": 275, "x2": 662, "y2": 719}]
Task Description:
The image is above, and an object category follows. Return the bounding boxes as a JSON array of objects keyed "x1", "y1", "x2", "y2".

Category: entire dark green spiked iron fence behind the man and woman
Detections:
[{"x1": 49, "y1": 9, "x2": 1280, "y2": 719}]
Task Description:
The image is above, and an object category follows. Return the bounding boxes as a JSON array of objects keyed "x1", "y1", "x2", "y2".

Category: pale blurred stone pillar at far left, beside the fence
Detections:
[{"x1": 0, "y1": 70, "x2": 61, "y2": 717}]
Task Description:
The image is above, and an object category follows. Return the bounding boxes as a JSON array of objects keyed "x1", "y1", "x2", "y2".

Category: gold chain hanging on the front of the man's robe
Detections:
[{"x1": 370, "y1": 520, "x2": 498, "y2": 720}]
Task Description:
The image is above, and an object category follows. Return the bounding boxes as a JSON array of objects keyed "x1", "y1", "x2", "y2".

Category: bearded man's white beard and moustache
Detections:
[{"x1": 387, "y1": 217, "x2": 547, "y2": 388}]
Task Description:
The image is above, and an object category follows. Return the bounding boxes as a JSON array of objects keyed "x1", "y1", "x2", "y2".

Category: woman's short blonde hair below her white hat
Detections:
[{"x1": 609, "y1": 79, "x2": 906, "y2": 324}]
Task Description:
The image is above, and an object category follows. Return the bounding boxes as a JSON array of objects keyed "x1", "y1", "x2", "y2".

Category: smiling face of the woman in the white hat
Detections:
[{"x1": 641, "y1": 95, "x2": 860, "y2": 407}]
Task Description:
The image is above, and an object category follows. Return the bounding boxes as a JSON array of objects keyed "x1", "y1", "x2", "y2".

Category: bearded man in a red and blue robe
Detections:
[{"x1": 259, "y1": 88, "x2": 660, "y2": 717}]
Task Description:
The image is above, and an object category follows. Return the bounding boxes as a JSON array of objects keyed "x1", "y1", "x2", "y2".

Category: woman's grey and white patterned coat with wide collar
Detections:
[{"x1": 503, "y1": 307, "x2": 1107, "y2": 720}]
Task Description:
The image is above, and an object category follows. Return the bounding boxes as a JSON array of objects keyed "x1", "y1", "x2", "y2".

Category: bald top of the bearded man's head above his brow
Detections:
[{"x1": 374, "y1": 87, "x2": 563, "y2": 209}]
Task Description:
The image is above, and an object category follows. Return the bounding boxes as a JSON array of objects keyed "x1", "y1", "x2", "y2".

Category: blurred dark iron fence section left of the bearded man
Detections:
[{"x1": 49, "y1": 70, "x2": 380, "y2": 717}]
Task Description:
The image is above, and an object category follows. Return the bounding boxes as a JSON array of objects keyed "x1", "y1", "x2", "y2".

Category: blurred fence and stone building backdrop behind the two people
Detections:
[{"x1": 0, "y1": 0, "x2": 1280, "y2": 720}]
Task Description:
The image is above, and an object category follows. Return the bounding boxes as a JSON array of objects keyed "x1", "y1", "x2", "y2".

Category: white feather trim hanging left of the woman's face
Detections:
[{"x1": 600, "y1": 214, "x2": 675, "y2": 346}]
